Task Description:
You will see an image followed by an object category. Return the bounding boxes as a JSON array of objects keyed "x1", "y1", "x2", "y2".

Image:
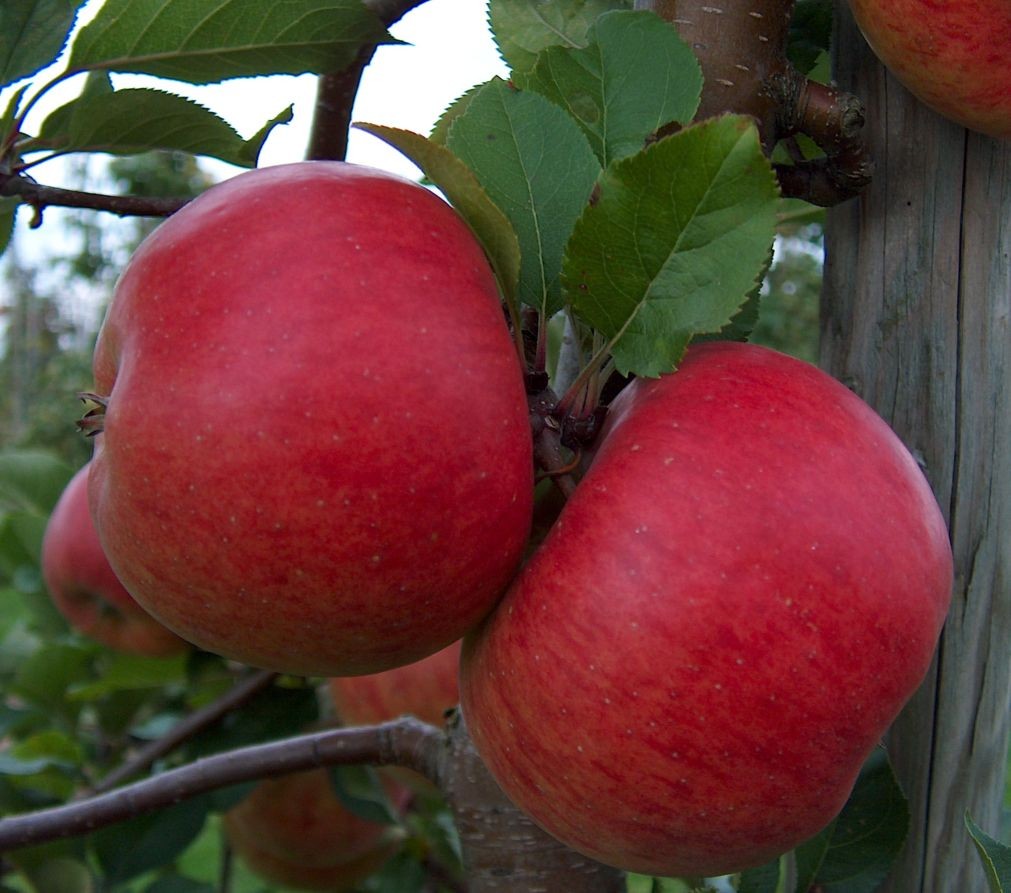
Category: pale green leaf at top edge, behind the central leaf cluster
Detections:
[{"x1": 488, "y1": 0, "x2": 632, "y2": 71}]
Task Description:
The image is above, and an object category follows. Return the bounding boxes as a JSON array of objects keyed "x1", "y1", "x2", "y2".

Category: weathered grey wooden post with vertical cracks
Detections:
[{"x1": 821, "y1": 2, "x2": 1011, "y2": 893}]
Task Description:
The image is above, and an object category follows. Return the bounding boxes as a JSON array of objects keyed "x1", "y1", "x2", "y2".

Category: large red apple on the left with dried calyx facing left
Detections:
[{"x1": 91, "y1": 162, "x2": 533, "y2": 676}]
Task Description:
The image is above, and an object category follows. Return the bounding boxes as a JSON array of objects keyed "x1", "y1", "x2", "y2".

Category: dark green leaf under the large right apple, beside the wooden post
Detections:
[{"x1": 797, "y1": 748, "x2": 909, "y2": 893}]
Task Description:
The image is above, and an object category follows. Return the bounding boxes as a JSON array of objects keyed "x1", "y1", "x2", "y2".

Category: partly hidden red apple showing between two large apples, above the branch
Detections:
[{"x1": 328, "y1": 641, "x2": 461, "y2": 726}]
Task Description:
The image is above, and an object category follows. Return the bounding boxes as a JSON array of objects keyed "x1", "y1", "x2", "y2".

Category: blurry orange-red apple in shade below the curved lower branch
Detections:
[{"x1": 224, "y1": 769, "x2": 408, "y2": 893}]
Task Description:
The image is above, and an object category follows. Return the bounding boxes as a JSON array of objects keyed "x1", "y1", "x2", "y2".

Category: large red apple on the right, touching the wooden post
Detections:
[{"x1": 460, "y1": 343, "x2": 952, "y2": 877}]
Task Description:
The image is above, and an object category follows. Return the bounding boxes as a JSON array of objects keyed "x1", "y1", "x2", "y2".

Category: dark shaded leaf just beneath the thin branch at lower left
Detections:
[{"x1": 91, "y1": 797, "x2": 207, "y2": 884}]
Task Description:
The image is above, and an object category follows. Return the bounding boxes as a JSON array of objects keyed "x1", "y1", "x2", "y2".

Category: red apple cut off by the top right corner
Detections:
[{"x1": 849, "y1": 0, "x2": 1011, "y2": 140}]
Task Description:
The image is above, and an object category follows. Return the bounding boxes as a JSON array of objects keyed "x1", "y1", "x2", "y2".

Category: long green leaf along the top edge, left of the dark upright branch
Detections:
[{"x1": 70, "y1": 0, "x2": 395, "y2": 84}]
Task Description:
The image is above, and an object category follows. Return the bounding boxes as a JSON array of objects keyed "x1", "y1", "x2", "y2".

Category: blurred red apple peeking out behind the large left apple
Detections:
[{"x1": 41, "y1": 465, "x2": 189, "y2": 657}]
